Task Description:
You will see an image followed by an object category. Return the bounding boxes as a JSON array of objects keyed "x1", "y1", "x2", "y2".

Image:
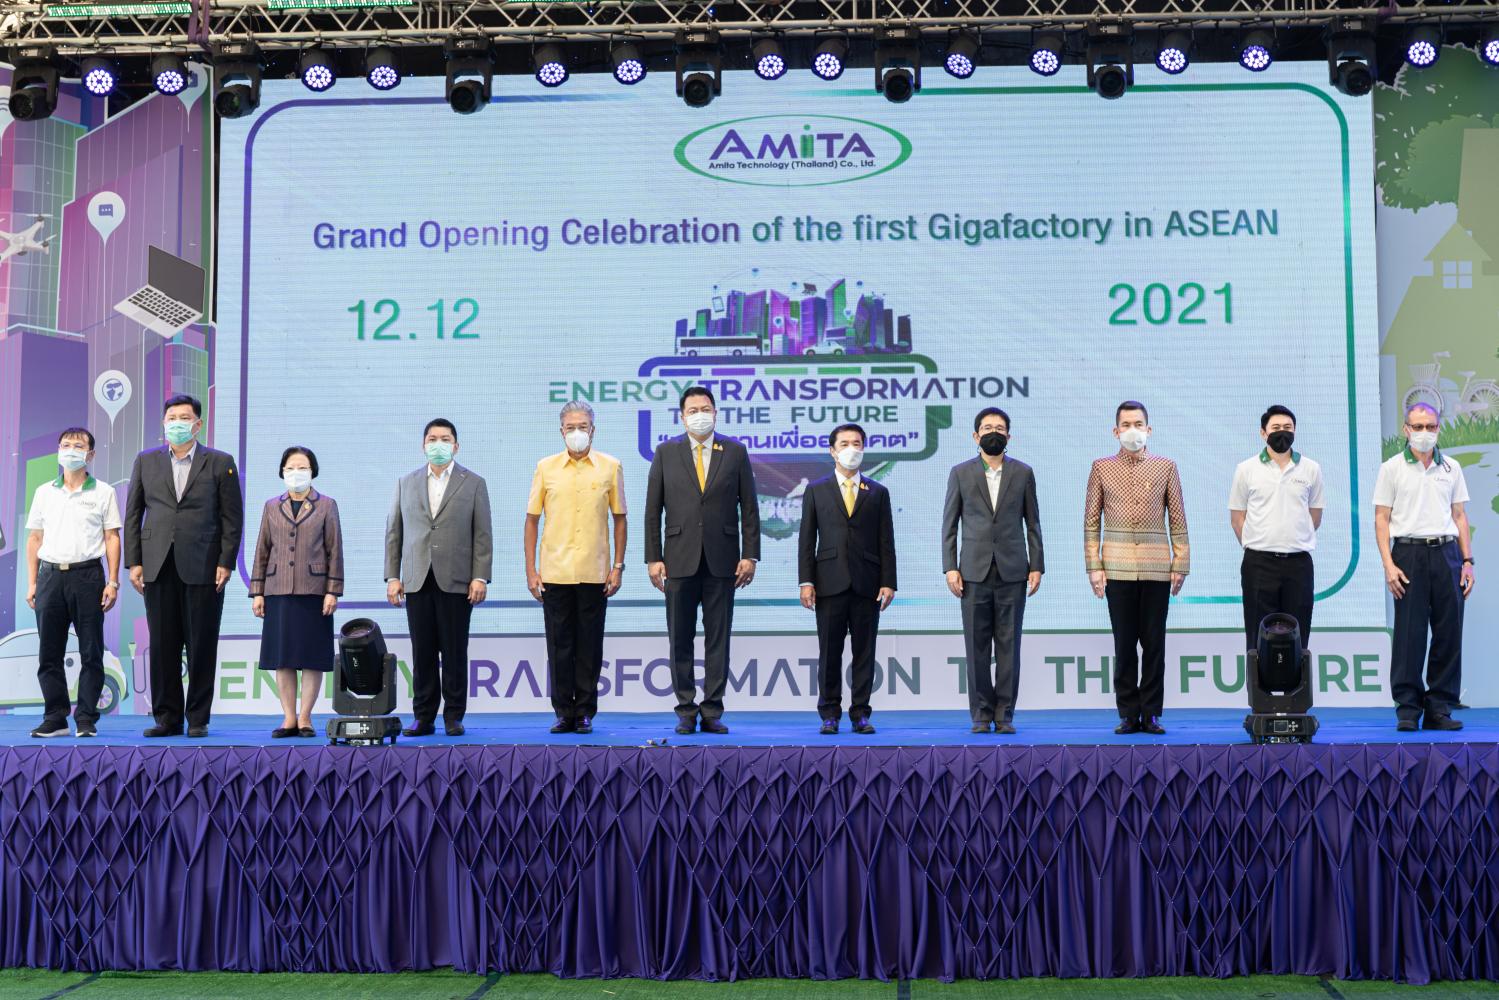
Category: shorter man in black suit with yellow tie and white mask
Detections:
[{"x1": 797, "y1": 424, "x2": 895, "y2": 735}]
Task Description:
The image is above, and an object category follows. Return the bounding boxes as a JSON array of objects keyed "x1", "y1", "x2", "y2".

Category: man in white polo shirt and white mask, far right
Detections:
[{"x1": 1375, "y1": 403, "x2": 1474, "y2": 733}]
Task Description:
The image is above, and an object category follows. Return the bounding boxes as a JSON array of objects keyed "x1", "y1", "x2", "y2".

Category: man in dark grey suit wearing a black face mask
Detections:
[{"x1": 941, "y1": 406, "x2": 1046, "y2": 733}]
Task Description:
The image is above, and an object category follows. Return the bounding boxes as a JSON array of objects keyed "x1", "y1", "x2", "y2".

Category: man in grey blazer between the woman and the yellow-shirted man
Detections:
[{"x1": 385, "y1": 417, "x2": 495, "y2": 736}]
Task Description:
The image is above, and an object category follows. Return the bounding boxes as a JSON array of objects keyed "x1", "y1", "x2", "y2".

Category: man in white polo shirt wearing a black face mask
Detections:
[{"x1": 1228, "y1": 405, "x2": 1324, "y2": 649}]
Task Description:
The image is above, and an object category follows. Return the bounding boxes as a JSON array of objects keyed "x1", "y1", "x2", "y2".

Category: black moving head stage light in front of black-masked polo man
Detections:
[{"x1": 1244, "y1": 613, "x2": 1316, "y2": 744}]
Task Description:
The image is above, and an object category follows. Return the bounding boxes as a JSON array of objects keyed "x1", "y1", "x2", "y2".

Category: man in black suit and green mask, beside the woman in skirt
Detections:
[{"x1": 124, "y1": 396, "x2": 244, "y2": 736}]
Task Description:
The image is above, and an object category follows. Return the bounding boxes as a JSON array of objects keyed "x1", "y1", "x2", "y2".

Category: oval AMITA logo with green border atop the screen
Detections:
[{"x1": 676, "y1": 114, "x2": 911, "y2": 187}]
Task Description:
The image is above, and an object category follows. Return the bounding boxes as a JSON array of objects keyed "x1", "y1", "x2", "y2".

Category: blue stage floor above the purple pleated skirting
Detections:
[{"x1": 0, "y1": 708, "x2": 1499, "y2": 747}]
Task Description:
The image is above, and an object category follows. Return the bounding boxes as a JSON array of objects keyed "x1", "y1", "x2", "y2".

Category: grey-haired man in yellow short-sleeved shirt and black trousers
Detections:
[{"x1": 525, "y1": 400, "x2": 627, "y2": 733}]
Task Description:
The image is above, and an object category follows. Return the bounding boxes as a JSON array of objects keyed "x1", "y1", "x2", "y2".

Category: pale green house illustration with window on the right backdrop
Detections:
[{"x1": 1379, "y1": 129, "x2": 1499, "y2": 439}]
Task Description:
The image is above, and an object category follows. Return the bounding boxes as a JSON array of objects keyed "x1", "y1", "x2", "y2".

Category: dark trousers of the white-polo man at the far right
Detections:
[{"x1": 1390, "y1": 541, "x2": 1463, "y2": 721}]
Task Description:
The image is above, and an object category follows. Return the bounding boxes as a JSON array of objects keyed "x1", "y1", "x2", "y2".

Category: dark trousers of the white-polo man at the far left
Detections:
[{"x1": 36, "y1": 559, "x2": 103, "y2": 724}]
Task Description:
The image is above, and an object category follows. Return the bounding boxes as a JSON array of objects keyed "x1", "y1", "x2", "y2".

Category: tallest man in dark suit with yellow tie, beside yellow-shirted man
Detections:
[{"x1": 646, "y1": 385, "x2": 760, "y2": 735}]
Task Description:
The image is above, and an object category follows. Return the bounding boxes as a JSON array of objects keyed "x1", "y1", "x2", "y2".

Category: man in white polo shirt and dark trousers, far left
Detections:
[{"x1": 25, "y1": 427, "x2": 120, "y2": 736}]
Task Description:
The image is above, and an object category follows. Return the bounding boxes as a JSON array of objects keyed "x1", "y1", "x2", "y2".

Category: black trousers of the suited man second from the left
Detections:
[{"x1": 145, "y1": 549, "x2": 223, "y2": 729}]
